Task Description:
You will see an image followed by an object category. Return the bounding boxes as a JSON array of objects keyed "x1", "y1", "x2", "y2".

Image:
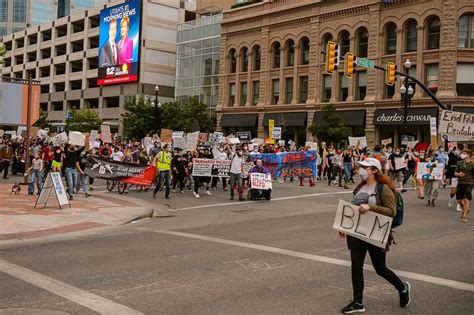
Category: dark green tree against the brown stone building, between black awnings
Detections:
[{"x1": 308, "y1": 104, "x2": 352, "y2": 144}]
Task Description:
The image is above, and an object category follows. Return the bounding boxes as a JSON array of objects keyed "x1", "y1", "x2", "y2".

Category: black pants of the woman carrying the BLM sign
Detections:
[{"x1": 347, "y1": 235, "x2": 405, "y2": 304}]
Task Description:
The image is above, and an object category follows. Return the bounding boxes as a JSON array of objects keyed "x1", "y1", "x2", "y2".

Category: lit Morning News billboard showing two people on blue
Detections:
[{"x1": 97, "y1": 0, "x2": 141, "y2": 85}]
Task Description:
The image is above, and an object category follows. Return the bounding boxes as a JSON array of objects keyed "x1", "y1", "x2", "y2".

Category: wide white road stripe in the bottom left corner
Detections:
[{"x1": 0, "y1": 259, "x2": 143, "y2": 315}]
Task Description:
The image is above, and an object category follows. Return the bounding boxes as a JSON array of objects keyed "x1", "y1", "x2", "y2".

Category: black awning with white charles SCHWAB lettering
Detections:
[{"x1": 374, "y1": 107, "x2": 438, "y2": 126}]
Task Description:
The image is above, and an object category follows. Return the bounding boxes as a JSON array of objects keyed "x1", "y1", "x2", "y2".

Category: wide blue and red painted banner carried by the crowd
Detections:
[{"x1": 250, "y1": 150, "x2": 318, "y2": 179}]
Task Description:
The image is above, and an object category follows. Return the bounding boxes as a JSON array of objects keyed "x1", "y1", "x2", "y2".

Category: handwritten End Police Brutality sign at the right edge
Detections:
[{"x1": 438, "y1": 110, "x2": 474, "y2": 141}]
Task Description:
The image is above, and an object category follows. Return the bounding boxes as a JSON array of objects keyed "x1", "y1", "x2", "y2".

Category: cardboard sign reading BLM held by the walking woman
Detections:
[{"x1": 333, "y1": 200, "x2": 393, "y2": 248}]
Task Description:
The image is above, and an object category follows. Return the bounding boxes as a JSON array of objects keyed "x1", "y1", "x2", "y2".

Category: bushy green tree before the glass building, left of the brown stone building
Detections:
[{"x1": 161, "y1": 97, "x2": 215, "y2": 132}]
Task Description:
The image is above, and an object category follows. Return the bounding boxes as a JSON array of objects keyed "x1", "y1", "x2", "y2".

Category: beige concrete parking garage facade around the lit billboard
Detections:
[{"x1": 1, "y1": 0, "x2": 195, "y2": 132}]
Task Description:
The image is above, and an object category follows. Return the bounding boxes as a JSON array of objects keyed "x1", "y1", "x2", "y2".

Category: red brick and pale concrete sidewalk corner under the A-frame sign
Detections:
[{"x1": 0, "y1": 182, "x2": 158, "y2": 241}]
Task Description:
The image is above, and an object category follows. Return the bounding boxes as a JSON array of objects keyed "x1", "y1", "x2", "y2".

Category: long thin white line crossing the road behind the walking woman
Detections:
[{"x1": 150, "y1": 228, "x2": 474, "y2": 292}]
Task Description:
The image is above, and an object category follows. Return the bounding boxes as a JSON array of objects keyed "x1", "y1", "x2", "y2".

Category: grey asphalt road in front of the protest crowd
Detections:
[{"x1": 0, "y1": 182, "x2": 474, "y2": 314}]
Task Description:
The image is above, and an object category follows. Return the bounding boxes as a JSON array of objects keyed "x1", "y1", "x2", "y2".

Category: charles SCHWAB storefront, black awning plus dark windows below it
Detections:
[{"x1": 373, "y1": 107, "x2": 438, "y2": 147}]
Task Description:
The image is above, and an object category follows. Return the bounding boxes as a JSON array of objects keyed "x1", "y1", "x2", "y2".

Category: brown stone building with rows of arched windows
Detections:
[{"x1": 217, "y1": 0, "x2": 474, "y2": 146}]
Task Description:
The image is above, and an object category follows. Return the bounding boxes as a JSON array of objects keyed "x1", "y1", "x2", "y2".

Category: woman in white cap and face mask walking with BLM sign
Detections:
[{"x1": 339, "y1": 158, "x2": 411, "y2": 314}]
